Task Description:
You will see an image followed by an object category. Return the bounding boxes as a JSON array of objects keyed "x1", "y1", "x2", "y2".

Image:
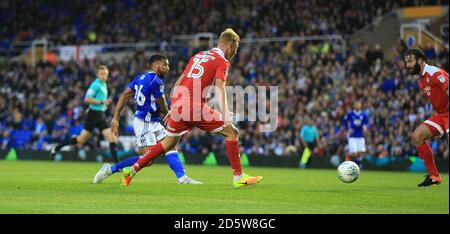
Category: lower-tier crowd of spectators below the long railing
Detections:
[{"x1": 0, "y1": 39, "x2": 448, "y2": 162}]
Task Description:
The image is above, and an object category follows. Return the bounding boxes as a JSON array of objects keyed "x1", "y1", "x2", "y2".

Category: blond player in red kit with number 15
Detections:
[{"x1": 122, "y1": 28, "x2": 262, "y2": 188}]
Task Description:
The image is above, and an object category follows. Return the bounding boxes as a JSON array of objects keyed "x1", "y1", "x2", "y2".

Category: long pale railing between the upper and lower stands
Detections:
[{"x1": 0, "y1": 32, "x2": 347, "y2": 64}]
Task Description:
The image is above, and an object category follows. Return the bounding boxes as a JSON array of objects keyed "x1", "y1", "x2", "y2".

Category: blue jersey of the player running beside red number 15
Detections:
[{"x1": 128, "y1": 72, "x2": 164, "y2": 121}]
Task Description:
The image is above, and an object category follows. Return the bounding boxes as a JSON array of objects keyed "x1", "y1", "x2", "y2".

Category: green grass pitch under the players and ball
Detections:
[{"x1": 0, "y1": 161, "x2": 449, "y2": 214}]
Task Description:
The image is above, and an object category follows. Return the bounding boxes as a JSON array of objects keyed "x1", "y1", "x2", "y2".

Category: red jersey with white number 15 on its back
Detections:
[{"x1": 172, "y1": 48, "x2": 230, "y2": 106}]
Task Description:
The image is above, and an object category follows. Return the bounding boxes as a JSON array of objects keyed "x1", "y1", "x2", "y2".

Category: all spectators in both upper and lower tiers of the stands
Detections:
[{"x1": 0, "y1": 0, "x2": 449, "y2": 163}]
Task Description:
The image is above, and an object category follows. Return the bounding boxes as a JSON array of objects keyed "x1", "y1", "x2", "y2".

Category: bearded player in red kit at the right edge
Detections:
[{"x1": 404, "y1": 48, "x2": 449, "y2": 187}]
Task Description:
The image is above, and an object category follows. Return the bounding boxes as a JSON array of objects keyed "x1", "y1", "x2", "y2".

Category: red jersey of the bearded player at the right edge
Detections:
[{"x1": 418, "y1": 64, "x2": 449, "y2": 114}]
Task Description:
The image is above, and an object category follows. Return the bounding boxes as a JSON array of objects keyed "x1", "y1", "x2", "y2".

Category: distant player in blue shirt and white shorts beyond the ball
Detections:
[{"x1": 344, "y1": 101, "x2": 369, "y2": 166}]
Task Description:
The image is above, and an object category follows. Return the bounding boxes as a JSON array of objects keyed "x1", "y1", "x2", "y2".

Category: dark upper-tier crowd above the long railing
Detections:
[{"x1": 0, "y1": 0, "x2": 442, "y2": 46}]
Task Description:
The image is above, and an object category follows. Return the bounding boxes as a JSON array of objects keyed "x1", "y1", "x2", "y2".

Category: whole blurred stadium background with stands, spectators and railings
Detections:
[{"x1": 0, "y1": 0, "x2": 449, "y2": 171}]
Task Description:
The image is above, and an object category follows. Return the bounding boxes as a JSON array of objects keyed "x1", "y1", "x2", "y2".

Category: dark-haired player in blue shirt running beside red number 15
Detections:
[{"x1": 94, "y1": 55, "x2": 201, "y2": 184}]
